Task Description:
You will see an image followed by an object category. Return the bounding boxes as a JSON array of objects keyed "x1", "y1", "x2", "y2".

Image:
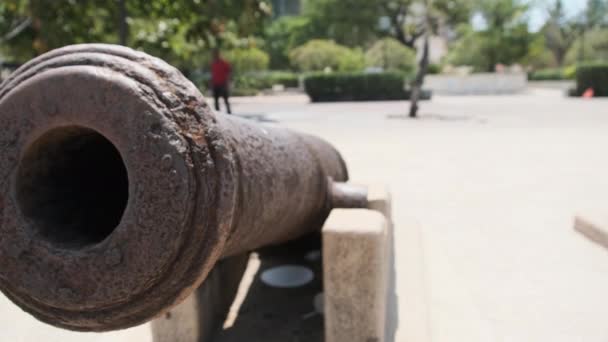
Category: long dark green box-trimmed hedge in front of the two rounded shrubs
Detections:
[{"x1": 304, "y1": 72, "x2": 430, "y2": 102}]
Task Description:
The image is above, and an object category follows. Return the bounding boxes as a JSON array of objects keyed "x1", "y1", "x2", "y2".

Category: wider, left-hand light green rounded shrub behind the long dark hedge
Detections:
[{"x1": 289, "y1": 39, "x2": 365, "y2": 71}]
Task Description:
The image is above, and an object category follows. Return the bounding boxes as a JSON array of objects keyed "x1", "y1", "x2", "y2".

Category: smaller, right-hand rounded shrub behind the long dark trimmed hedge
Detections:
[{"x1": 365, "y1": 38, "x2": 416, "y2": 74}]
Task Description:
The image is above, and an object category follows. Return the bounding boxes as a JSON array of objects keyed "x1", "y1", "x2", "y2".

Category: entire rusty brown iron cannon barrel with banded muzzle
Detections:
[{"x1": 0, "y1": 44, "x2": 362, "y2": 331}]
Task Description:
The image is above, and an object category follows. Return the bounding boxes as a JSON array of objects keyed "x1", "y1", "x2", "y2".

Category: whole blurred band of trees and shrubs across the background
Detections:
[{"x1": 0, "y1": 0, "x2": 608, "y2": 94}]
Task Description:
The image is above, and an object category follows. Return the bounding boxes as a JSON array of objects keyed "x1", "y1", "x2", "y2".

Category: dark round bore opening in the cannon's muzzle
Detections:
[{"x1": 16, "y1": 126, "x2": 129, "y2": 249}]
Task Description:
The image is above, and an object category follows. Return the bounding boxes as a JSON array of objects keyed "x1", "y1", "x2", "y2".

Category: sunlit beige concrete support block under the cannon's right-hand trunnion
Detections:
[{"x1": 323, "y1": 187, "x2": 397, "y2": 342}]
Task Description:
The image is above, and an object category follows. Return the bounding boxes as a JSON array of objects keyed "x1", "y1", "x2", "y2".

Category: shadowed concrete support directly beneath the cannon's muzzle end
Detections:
[{"x1": 152, "y1": 253, "x2": 249, "y2": 342}]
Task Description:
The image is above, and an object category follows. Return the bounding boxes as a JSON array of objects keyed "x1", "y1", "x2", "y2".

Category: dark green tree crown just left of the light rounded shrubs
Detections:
[{"x1": 264, "y1": 16, "x2": 314, "y2": 69}]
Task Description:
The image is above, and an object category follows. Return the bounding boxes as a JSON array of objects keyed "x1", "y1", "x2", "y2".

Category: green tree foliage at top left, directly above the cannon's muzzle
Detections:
[{"x1": 0, "y1": 0, "x2": 271, "y2": 69}]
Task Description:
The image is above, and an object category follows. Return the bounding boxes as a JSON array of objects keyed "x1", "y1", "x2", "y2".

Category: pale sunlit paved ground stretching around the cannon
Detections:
[{"x1": 0, "y1": 90, "x2": 608, "y2": 342}]
